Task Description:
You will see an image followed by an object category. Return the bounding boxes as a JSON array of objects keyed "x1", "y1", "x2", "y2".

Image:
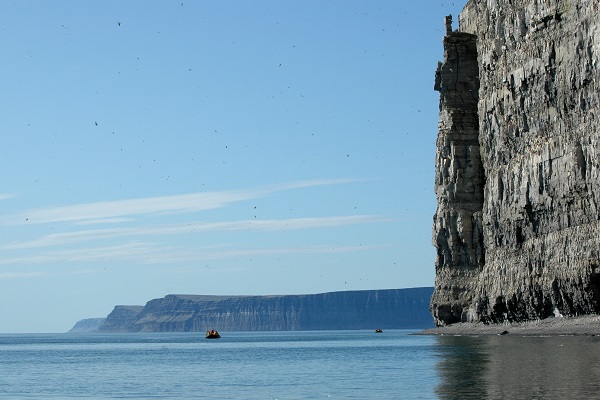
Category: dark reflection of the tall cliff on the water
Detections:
[{"x1": 436, "y1": 336, "x2": 600, "y2": 400}]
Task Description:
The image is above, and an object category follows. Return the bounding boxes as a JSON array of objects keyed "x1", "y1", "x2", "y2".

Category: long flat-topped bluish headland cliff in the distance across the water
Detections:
[{"x1": 99, "y1": 287, "x2": 433, "y2": 332}]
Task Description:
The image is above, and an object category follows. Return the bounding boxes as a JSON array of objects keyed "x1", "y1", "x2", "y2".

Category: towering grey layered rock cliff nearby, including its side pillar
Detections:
[{"x1": 431, "y1": 0, "x2": 600, "y2": 325}]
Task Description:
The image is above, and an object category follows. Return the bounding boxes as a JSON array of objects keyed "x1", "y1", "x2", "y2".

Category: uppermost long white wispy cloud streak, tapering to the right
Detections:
[{"x1": 0, "y1": 179, "x2": 357, "y2": 225}]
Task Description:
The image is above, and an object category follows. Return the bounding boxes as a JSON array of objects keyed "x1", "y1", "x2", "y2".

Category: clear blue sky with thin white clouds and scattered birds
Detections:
[{"x1": 0, "y1": 0, "x2": 463, "y2": 333}]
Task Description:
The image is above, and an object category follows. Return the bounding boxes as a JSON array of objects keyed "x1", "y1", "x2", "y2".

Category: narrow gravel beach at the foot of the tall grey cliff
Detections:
[{"x1": 415, "y1": 315, "x2": 600, "y2": 336}]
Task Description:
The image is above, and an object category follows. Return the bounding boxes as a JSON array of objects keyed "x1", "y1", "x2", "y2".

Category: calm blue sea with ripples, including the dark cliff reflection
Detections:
[{"x1": 0, "y1": 330, "x2": 600, "y2": 400}]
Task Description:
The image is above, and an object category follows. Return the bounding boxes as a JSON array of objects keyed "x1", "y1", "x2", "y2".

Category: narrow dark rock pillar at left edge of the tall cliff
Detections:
[{"x1": 432, "y1": 20, "x2": 485, "y2": 323}]
